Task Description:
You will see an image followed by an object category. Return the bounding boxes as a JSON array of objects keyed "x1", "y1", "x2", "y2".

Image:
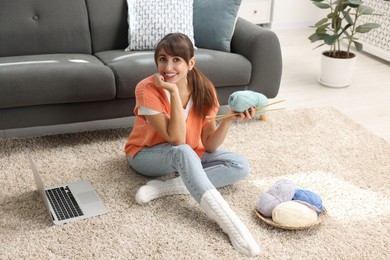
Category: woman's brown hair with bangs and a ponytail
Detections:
[{"x1": 154, "y1": 33, "x2": 217, "y2": 117}]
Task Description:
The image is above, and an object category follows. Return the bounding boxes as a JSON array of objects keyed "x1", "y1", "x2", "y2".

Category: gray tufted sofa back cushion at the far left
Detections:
[{"x1": 0, "y1": 0, "x2": 91, "y2": 57}]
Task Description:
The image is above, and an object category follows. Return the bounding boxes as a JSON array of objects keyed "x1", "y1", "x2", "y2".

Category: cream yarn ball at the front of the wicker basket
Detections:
[{"x1": 272, "y1": 200, "x2": 318, "y2": 227}]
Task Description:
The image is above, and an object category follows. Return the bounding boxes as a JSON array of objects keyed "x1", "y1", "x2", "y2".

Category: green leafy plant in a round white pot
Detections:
[{"x1": 309, "y1": 0, "x2": 390, "y2": 87}]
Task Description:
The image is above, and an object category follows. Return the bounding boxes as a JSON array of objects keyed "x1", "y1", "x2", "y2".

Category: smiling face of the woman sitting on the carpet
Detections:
[{"x1": 157, "y1": 49, "x2": 195, "y2": 84}]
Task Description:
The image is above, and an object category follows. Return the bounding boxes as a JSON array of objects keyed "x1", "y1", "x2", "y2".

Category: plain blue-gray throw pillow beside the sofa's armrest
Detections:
[{"x1": 193, "y1": 0, "x2": 241, "y2": 52}]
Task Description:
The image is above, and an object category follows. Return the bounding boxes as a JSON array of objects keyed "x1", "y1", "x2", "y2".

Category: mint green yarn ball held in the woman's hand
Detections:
[{"x1": 228, "y1": 90, "x2": 268, "y2": 112}]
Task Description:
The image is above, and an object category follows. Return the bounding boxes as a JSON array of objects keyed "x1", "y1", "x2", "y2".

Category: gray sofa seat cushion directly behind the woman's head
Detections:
[{"x1": 96, "y1": 49, "x2": 252, "y2": 98}]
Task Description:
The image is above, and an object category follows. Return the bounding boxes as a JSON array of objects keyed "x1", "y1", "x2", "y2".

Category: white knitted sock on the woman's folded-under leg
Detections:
[{"x1": 135, "y1": 176, "x2": 190, "y2": 204}]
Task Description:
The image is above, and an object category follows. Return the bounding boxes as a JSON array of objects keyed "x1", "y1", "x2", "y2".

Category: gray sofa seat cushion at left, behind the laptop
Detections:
[{"x1": 0, "y1": 54, "x2": 116, "y2": 108}]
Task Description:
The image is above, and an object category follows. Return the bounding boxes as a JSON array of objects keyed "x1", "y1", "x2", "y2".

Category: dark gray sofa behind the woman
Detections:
[{"x1": 0, "y1": 0, "x2": 282, "y2": 136}]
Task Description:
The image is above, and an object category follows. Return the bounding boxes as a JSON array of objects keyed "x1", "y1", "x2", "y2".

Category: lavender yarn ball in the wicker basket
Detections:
[{"x1": 256, "y1": 180, "x2": 295, "y2": 217}]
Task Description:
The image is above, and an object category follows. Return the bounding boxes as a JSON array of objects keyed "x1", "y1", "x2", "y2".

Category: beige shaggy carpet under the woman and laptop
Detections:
[{"x1": 0, "y1": 108, "x2": 390, "y2": 259}]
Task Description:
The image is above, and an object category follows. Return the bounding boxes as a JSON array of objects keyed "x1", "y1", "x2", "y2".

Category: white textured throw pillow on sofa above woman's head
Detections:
[{"x1": 126, "y1": 0, "x2": 195, "y2": 51}]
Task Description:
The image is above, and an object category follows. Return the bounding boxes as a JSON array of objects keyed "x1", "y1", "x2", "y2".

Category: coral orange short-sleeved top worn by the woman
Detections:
[{"x1": 125, "y1": 76, "x2": 219, "y2": 157}]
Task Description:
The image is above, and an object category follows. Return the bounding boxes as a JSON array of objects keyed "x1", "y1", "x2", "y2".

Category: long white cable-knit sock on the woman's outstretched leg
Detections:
[{"x1": 200, "y1": 190, "x2": 260, "y2": 256}]
